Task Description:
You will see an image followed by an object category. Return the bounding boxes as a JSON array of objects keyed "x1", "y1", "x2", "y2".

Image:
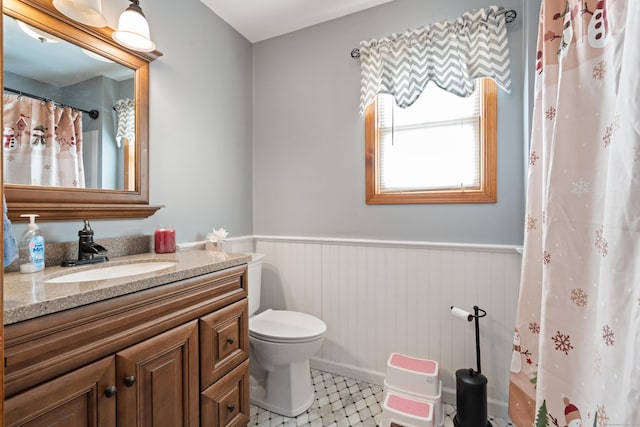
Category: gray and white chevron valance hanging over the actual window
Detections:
[{"x1": 360, "y1": 6, "x2": 511, "y2": 114}]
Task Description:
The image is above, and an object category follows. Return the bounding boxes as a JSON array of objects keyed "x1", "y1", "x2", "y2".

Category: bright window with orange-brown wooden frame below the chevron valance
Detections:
[{"x1": 365, "y1": 78, "x2": 497, "y2": 204}]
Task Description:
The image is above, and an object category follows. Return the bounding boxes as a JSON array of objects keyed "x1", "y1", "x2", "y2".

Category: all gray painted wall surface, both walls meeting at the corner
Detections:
[{"x1": 7, "y1": 0, "x2": 539, "y2": 244}]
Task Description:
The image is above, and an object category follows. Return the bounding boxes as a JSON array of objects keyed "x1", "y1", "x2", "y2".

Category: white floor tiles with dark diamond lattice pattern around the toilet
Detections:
[{"x1": 249, "y1": 369, "x2": 512, "y2": 427}]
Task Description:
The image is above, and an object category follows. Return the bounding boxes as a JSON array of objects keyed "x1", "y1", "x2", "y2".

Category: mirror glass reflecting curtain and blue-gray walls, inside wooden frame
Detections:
[{"x1": 3, "y1": 15, "x2": 136, "y2": 191}]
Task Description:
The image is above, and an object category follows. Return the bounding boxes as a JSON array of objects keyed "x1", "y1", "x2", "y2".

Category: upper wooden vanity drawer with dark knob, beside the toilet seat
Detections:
[{"x1": 199, "y1": 298, "x2": 249, "y2": 390}]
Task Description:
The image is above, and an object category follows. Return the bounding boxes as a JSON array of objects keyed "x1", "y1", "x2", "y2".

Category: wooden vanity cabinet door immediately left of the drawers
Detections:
[{"x1": 116, "y1": 320, "x2": 199, "y2": 427}]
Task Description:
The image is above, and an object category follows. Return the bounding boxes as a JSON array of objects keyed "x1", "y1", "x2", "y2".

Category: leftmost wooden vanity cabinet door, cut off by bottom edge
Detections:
[{"x1": 5, "y1": 357, "x2": 116, "y2": 427}]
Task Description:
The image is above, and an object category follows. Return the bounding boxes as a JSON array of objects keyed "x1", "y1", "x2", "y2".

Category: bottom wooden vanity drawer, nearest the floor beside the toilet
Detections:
[{"x1": 200, "y1": 360, "x2": 250, "y2": 427}]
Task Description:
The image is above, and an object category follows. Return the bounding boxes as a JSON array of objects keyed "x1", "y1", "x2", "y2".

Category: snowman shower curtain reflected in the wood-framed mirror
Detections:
[{"x1": 2, "y1": 94, "x2": 85, "y2": 188}]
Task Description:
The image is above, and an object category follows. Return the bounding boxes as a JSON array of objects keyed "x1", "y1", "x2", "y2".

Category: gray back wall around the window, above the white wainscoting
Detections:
[{"x1": 253, "y1": 0, "x2": 537, "y2": 244}]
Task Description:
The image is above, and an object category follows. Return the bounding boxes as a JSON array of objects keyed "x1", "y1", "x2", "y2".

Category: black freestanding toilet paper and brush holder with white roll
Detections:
[{"x1": 451, "y1": 305, "x2": 491, "y2": 427}]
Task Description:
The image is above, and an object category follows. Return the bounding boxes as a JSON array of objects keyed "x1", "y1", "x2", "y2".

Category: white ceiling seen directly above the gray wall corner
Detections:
[{"x1": 200, "y1": 0, "x2": 393, "y2": 43}]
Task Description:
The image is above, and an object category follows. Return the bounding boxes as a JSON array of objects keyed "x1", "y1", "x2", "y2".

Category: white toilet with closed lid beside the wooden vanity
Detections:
[{"x1": 249, "y1": 253, "x2": 327, "y2": 417}]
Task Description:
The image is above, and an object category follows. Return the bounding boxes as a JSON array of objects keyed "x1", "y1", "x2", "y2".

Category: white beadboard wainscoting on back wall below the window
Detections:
[{"x1": 255, "y1": 236, "x2": 521, "y2": 416}]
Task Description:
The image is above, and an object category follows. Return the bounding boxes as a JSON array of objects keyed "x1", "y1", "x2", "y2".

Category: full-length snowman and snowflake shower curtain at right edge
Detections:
[{"x1": 509, "y1": 0, "x2": 640, "y2": 427}]
